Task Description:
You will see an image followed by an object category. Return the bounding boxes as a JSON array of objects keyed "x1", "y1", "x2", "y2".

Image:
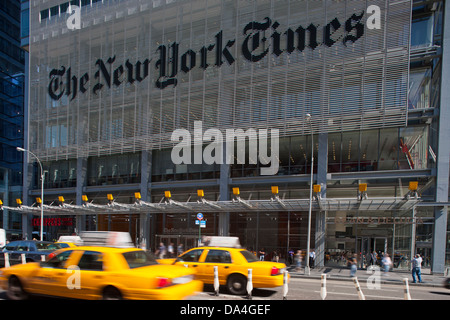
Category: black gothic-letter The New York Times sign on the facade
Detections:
[{"x1": 48, "y1": 11, "x2": 365, "y2": 100}]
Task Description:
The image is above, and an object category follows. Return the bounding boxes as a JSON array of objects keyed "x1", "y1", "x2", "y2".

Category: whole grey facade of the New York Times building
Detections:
[{"x1": 10, "y1": 0, "x2": 450, "y2": 273}]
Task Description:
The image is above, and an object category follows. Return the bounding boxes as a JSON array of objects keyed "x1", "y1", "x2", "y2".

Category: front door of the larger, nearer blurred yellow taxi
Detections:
[{"x1": 30, "y1": 250, "x2": 77, "y2": 297}]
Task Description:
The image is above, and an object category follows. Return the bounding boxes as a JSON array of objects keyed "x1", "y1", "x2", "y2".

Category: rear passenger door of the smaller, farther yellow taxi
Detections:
[{"x1": 198, "y1": 249, "x2": 232, "y2": 285}]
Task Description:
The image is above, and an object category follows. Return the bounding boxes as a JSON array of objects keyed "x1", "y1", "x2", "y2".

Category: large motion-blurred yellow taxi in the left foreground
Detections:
[{"x1": 0, "y1": 246, "x2": 203, "y2": 300}]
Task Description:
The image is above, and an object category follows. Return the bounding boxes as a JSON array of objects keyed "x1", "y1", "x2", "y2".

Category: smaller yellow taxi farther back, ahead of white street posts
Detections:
[{"x1": 159, "y1": 246, "x2": 286, "y2": 295}]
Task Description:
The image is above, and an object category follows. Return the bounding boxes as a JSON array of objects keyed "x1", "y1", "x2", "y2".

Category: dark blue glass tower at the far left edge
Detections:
[{"x1": 0, "y1": 0, "x2": 25, "y2": 237}]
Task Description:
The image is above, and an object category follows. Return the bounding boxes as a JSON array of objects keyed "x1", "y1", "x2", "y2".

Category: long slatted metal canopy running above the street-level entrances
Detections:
[{"x1": 3, "y1": 197, "x2": 420, "y2": 215}]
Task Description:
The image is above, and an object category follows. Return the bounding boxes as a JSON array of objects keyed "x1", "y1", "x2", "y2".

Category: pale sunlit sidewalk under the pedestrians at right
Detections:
[{"x1": 287, "y1": 266, "x2": 447, "y2": 287}]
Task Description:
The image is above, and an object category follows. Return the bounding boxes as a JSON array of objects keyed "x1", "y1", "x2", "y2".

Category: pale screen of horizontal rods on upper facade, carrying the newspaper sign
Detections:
[{"x1": 29, "y1": 0, "x2": 412, "y2": 161}]
